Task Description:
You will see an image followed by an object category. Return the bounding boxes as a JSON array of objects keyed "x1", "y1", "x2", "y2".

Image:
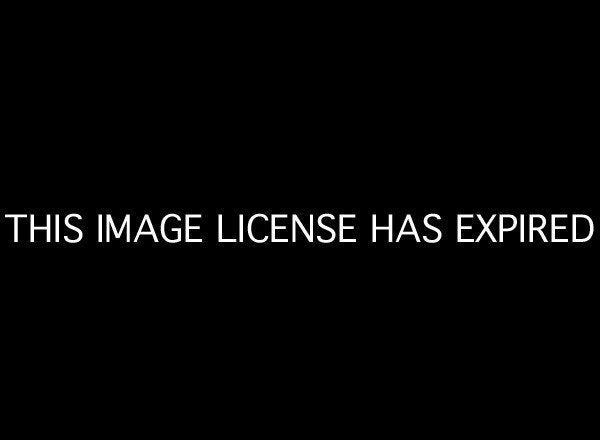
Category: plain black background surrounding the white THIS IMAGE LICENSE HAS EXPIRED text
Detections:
[{"x1": 1, "y1": 5, "x2": 598, "y2": 433}]
